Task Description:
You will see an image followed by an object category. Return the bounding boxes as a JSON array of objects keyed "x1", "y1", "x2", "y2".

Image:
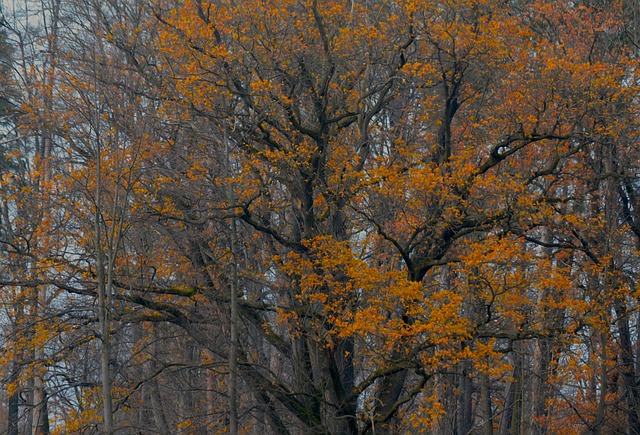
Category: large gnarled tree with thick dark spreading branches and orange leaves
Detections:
[{"x1": 139, "y1": 2, "x2": 634, "y2": 432}]
